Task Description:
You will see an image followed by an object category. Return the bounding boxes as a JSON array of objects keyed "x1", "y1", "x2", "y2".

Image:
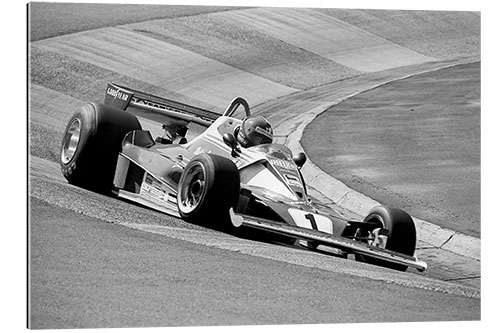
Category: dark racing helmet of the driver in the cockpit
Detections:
[{"x1": 236, "y1": 116, "x2": 273, "y2": 148}]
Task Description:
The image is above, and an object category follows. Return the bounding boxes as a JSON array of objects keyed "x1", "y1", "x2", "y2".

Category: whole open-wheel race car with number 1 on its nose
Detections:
[{"x1": 60, "y1": 83, "x2": 427, "y2": 271}]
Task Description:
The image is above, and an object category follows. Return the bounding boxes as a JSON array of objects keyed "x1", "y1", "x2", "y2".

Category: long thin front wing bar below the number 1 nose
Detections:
[{"x1": 229, "y1": 208, "x2": 427, "y2": 272}]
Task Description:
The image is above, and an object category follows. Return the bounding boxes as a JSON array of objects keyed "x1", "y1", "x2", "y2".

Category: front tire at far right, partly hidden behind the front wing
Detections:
[{"x1": 355, "y1": 206, "x2": 417, "y2": 271}]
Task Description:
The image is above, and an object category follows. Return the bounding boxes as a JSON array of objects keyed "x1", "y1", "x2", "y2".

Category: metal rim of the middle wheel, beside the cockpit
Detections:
[{"x1": 179, "y1": 164, "x2": 205, "y2": 213}]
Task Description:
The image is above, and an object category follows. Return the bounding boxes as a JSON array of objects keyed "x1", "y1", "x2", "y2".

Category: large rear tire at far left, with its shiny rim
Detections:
[{"x1": 60, "y1": 103, "x2": 141, "y2": 194}]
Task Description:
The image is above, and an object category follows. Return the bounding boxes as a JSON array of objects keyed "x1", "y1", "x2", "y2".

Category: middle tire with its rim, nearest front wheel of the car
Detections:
[{"x1": 177, "y1": 154, "x2": 240, "y2": 230}]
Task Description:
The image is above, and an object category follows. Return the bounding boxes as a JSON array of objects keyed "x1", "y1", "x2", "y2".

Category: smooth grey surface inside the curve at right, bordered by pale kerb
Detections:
[{"x1": 302, "y1": 62, "x2": 481, "y2": 237}]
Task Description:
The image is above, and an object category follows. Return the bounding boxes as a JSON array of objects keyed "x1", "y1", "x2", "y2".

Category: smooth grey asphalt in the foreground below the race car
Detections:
[{"x1": 30, "y1": 200, "x2": 479, "y2": 329}]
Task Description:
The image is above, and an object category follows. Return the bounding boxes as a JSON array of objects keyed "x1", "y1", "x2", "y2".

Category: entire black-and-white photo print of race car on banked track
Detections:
[{"x1": 21, "y1": 1, "x2": 488, "y2": 331}]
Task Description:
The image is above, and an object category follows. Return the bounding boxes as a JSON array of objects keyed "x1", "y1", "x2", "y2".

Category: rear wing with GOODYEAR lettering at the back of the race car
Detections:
[{"x1": 104, "y1": 83, "x2": 220, "y2": 127}]
